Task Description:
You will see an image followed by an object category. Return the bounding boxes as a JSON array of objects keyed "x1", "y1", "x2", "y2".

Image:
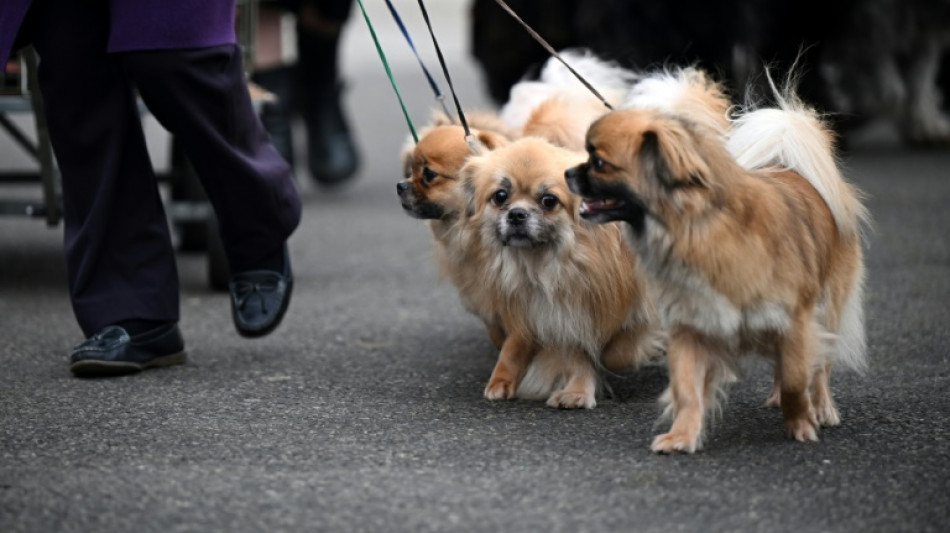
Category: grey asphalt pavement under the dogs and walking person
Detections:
[{"x1": 0, "y1": 2, "x2": 950, "y2": 532}]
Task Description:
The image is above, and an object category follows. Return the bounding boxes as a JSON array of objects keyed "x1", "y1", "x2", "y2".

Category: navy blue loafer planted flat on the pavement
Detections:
[{"x1": 69, "y1": 322, "x2": 185, "y2": 377}]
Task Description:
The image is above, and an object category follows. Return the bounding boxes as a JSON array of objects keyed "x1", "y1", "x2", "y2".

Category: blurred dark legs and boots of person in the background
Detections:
[{"x1": 253, "y1": 0, "x2": 359, "y2": 185}]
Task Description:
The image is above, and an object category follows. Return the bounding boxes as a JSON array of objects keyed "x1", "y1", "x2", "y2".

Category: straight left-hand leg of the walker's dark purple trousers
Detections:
[{"x1": 34, "y1": 0, "x2": 179, "y2": 336}]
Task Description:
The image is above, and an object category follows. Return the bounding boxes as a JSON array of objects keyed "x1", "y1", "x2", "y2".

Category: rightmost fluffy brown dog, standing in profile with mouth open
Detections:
[{"x1": 566, "y1": 89, "x2": 867, "y2": 453}]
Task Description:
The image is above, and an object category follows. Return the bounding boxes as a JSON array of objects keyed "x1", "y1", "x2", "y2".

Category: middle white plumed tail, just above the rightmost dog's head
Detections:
[{"x1": 622, "y1": 67, "x2": 730, "y2": 134}]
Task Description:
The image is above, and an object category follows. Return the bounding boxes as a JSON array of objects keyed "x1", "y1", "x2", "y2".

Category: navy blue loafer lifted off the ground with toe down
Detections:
[{"x1": 228, "y1": 245, "x2": 294, "y2": 337}]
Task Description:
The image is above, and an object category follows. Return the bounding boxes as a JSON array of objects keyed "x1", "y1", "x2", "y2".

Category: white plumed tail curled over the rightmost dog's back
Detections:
[{"x1": 727, "y1": 78, "x2": 868, "y2": 235}]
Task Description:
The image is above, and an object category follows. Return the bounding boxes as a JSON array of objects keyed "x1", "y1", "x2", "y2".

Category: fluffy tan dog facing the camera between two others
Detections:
[{"x1": 456, "y1": 138, "x2": 656, "y2": 408}]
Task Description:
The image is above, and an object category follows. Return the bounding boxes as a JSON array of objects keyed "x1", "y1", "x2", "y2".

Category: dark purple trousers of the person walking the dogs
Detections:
[{"x1": 33, "y1": 0, "x2": 301, "y2": 336}]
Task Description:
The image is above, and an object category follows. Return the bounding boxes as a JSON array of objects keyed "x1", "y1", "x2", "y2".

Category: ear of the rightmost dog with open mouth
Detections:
[{"x1": 639, "y1": 124, "x2": 710, "y2": 189}]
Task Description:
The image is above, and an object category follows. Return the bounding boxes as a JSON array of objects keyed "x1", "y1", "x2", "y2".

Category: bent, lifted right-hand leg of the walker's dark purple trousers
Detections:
[{"x1": 115, "y1": 45, "x2": 301, "y2": 272}]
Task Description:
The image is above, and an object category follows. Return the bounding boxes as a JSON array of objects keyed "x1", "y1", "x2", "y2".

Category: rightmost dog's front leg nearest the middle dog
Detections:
[{"x1": 650, "y1": 329, "x2": 712, "y2": 453}]
